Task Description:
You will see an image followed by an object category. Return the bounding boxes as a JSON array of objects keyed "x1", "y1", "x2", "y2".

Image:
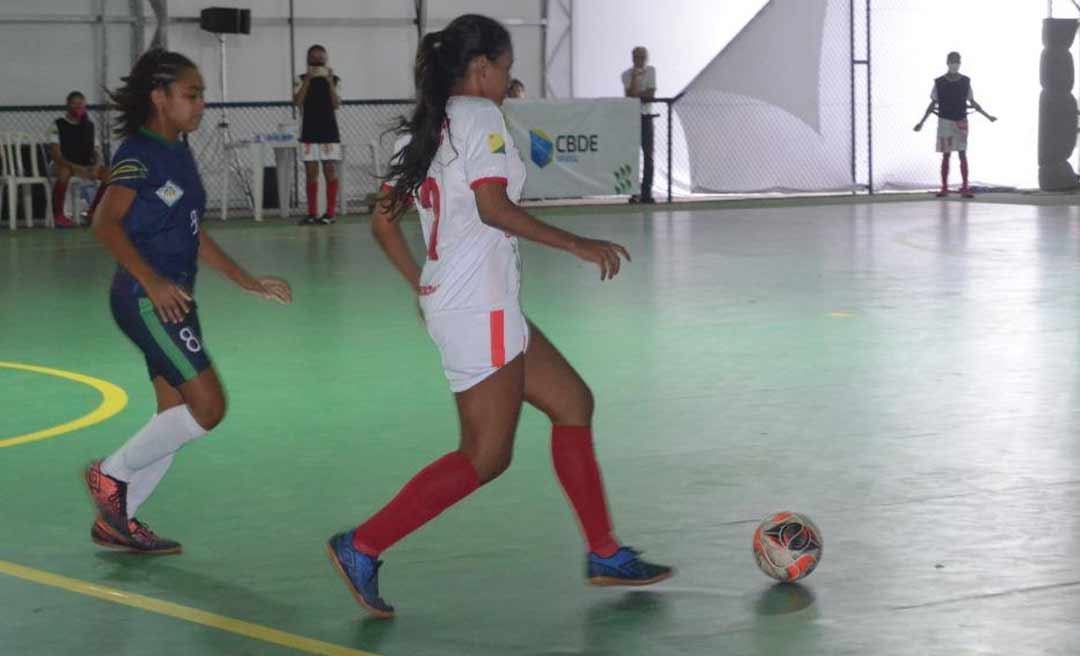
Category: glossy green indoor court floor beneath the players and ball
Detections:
[{"x1": 0, "y1": 200, "x2": 1080, "y2": 656}]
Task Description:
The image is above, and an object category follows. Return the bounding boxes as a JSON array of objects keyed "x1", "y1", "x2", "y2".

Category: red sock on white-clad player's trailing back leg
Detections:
[{"x1": 352, "y1": 451, "x2": 480, "y2": 558}]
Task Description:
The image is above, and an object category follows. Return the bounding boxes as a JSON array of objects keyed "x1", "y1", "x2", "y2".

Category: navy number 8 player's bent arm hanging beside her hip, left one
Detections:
[{"x1": 93, "y1": 185, "x2": 191, "y2": 323}]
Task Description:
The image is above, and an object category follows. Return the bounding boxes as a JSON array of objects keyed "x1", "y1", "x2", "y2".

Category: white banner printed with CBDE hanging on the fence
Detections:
[{"x1": 502, "y1": 98, "x2": 642, "y2": 198}]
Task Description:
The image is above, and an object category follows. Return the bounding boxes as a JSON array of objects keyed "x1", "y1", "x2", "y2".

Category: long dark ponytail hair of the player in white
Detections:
[{"x1": 387, "y1": 14, "x2": 511, "y2": 207}]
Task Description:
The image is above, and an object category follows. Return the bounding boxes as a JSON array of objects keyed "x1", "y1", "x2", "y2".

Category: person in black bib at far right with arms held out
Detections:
[{"x1": 915, "y1": 52, "x2": 998, "y2": 198}]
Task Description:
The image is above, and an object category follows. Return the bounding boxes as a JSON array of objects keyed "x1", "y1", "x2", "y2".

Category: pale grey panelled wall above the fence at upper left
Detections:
[{"x1": 0, "y1": 0, "x2": 542, "y2": 105}]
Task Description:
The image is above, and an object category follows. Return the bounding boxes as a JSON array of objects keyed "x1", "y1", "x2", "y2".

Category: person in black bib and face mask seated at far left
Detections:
[{"x1": 49, "y1": 91, "x2": 106, "y2": 228}]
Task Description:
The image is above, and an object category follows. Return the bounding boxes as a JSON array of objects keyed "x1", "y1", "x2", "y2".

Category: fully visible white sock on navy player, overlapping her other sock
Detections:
[{"x1": 102, "y1": 405, "x2": 206, "y2": 482}]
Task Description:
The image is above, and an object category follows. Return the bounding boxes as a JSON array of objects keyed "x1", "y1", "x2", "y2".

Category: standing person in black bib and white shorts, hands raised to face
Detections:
[{"x1": 293, "y1": 44, "x2": 341, "y2": 226}]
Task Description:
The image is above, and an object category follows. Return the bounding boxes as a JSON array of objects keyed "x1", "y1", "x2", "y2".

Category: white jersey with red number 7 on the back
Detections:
[{"x1": 391, "y1": 96, "x2": 525, "y2": 317}]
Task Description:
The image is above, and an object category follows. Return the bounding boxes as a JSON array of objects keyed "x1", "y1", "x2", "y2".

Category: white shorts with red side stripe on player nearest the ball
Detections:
[{"x1": 424, "y1": 307, "x2": 529, "y2": 393}]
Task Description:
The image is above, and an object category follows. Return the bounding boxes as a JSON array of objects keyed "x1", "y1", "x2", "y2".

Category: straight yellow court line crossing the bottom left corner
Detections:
[{"x1": 0, "y1": 560, "x2": 378, "y2": 656}]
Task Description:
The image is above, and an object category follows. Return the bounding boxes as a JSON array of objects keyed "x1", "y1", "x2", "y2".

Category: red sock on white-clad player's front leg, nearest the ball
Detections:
[{"x1": 551, "y1": 426, "x2": 619, "y2": 558}]
